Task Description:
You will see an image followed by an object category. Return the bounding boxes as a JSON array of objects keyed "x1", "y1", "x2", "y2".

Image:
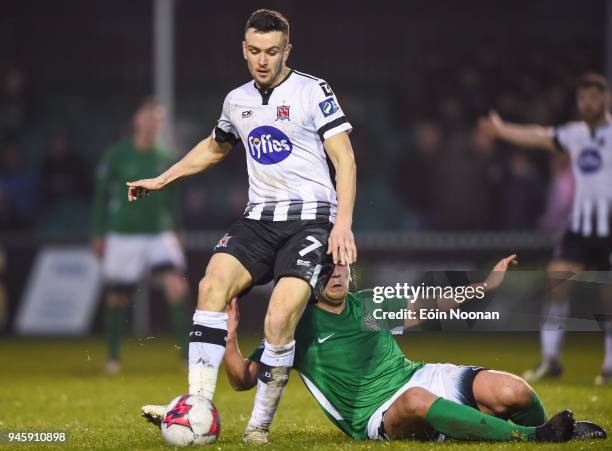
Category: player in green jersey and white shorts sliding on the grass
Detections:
[{"x1": 143, "y1": 255, "x2": 606, "y2": 441}]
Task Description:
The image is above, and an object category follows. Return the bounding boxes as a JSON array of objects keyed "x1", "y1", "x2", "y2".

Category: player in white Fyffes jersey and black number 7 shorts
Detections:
[{"x1": 128, "y1": 10, "x2": 357, "y2": 443}]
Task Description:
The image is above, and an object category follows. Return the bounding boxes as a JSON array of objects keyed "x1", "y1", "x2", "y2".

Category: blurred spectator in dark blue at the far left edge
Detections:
[{"x1": 0, "y1": 141, "x2": 38, "y2": 230}]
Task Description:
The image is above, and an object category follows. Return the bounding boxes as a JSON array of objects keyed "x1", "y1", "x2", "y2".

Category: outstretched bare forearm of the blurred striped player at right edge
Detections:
[{"x1": 478, "y1": 111, "x2": 557, "y2": 150}]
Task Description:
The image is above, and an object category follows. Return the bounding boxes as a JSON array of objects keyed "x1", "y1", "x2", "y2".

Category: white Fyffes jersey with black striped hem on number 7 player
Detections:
[{"x1": 213, "y1": 70, "x2": 352, "y2": 222}]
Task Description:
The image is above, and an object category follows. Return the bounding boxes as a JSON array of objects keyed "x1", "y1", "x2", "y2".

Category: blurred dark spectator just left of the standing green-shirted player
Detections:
[{"x1": 40, "y1": 129, "x2": 92, "y2": 209}]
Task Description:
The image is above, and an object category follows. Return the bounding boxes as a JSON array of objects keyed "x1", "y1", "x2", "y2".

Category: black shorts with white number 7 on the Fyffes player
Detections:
[{"x1": 214, "y1": 218, "x2": 333, "y2": 296}]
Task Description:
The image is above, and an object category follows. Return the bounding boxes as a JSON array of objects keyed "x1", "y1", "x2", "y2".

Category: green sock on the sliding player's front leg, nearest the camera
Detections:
[{"x1": 426, "y1": 398, "x2": 536, "y2": 442}]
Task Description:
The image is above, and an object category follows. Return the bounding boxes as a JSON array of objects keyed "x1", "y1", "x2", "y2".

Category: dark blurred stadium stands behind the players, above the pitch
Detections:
[{"x1": 0, "y1": 0, "x2": 612, "y2": 336}]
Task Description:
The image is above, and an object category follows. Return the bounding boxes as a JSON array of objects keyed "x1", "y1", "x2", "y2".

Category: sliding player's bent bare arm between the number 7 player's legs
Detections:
[{"x1": 223, "y1": 298, "x2": 259, "y2": 391}]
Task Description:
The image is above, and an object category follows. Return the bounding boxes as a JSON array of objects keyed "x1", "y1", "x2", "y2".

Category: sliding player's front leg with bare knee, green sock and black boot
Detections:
[{"x1": 383, "y1": 387, "x2": 574, "y2": 442}]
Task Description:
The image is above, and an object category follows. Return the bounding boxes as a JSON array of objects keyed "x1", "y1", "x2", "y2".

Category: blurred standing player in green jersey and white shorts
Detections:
[{"x1": 91, "y1": 99, "x2": 188, "y2": 374}]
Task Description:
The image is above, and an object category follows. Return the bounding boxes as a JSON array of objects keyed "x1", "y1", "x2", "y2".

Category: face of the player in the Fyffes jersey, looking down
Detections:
[{"x1": 242, "y1": 28, "x2": 291, "y2": 88}]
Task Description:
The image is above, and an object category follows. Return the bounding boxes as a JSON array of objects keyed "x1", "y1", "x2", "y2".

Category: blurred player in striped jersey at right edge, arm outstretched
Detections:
[{"x1": 479, "y1": 73, "x2": 612, "y2": 385}]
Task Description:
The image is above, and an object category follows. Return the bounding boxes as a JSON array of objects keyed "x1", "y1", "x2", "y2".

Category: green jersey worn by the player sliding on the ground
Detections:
[{"x1": 249, "y1": 290, "x2": 424, "y2": 440}]
